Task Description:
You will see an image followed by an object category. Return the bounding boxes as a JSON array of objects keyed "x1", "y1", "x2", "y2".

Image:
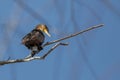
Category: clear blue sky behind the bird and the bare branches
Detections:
[{"x1": 0, "y1": 0, "x2": 120, "y2": 80}]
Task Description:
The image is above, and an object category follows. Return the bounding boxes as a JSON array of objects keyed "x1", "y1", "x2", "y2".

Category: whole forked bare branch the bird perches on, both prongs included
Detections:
[{"x1": 0, "y1": 24, "x2": 104, "y2": 65}]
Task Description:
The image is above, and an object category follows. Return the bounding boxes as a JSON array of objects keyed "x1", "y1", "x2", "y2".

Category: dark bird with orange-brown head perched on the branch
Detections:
[{"x1": 22, "y1": 24, "x2": 51, "y2": 58}]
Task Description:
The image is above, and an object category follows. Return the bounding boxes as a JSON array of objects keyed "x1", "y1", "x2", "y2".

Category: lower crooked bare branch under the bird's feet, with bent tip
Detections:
[{"x1": 0, "y1": 43, "x2": 68, "y2": 65}]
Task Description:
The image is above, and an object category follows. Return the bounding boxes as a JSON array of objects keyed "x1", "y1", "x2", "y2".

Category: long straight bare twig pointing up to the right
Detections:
[{"x1": 43, "y1": 24, "x2": 104, "y2": 47}]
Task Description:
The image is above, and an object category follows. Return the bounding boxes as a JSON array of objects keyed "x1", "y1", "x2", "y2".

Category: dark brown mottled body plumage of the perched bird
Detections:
[{"x1": 22, "y1": 29, "x2": 45, "y2": 50}]
